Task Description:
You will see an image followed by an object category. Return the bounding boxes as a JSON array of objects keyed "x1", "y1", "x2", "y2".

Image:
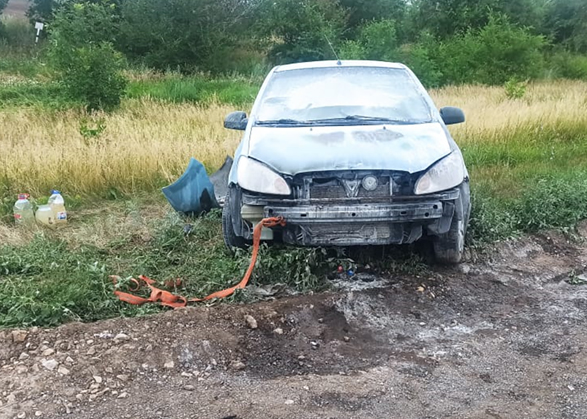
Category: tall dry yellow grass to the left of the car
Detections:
[{"x1": 0, "y1": 100, "x2": 240, "y2": 196}]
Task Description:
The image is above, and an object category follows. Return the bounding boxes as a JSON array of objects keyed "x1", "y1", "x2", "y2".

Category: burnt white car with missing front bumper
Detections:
[{"x1": 222, "y1": 61, "x2": 471, "y2": 263}]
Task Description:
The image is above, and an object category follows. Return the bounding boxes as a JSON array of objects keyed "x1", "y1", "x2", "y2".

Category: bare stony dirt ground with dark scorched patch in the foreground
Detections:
[{"x1": 0, "y1": 227, "x2": 587, "y2": 419}]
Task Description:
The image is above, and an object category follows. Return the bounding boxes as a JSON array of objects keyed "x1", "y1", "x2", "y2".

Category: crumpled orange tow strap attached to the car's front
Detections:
[{"x1": 110, "y1": 217, "x2": 285, "y2": 308}]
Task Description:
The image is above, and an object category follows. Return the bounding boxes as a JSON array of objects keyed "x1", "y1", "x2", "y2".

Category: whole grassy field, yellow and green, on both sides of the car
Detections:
[{"x1": 0, "y1": 72, "x2": 587, "y2": 327}]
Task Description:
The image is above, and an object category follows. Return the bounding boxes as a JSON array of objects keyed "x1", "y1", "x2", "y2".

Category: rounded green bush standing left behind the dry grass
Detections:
[{"x1": 50, "y1": 3, "x2": 127, "y2": 110}]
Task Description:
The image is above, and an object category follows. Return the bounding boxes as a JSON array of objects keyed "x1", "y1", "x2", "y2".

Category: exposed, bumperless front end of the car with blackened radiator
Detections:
[{"x1": 227, "y1": 171, "x2": 468, "y2": 246}]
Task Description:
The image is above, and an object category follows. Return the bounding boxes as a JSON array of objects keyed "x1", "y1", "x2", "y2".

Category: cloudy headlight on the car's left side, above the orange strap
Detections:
[{"x1": 237, "y1": 157, "x2": 291, "y2": 195}]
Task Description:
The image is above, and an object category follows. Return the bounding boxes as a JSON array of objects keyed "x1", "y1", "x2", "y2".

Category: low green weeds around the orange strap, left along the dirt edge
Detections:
[{"x1": 0, "y1": 212, "x2": 344, "y2": 327}]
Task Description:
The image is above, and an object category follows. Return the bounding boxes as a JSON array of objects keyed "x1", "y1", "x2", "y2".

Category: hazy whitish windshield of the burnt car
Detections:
[{"x1": 256, "y1": 67, "x2": 432, "y2": 125}]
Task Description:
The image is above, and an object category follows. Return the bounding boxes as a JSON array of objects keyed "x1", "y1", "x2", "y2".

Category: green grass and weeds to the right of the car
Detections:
[{"x1": 463, "y1": 122, "x2": 587, "y2": 244}]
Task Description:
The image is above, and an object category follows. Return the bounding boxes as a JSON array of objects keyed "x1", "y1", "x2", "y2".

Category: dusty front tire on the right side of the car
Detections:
[{"x1": 433, "y1": 184, "x2": 470, "y2": 265}]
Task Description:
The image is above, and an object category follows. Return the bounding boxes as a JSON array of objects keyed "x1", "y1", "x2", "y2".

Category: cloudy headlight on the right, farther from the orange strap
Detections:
[{"x1": 414, "y1": 150, "x2": 465, "y2": 195}]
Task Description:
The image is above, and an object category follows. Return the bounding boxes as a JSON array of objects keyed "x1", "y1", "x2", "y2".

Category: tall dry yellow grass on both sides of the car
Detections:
[{"x1": 0, "y1": 81, "x2": 587, "y2": 202}]
